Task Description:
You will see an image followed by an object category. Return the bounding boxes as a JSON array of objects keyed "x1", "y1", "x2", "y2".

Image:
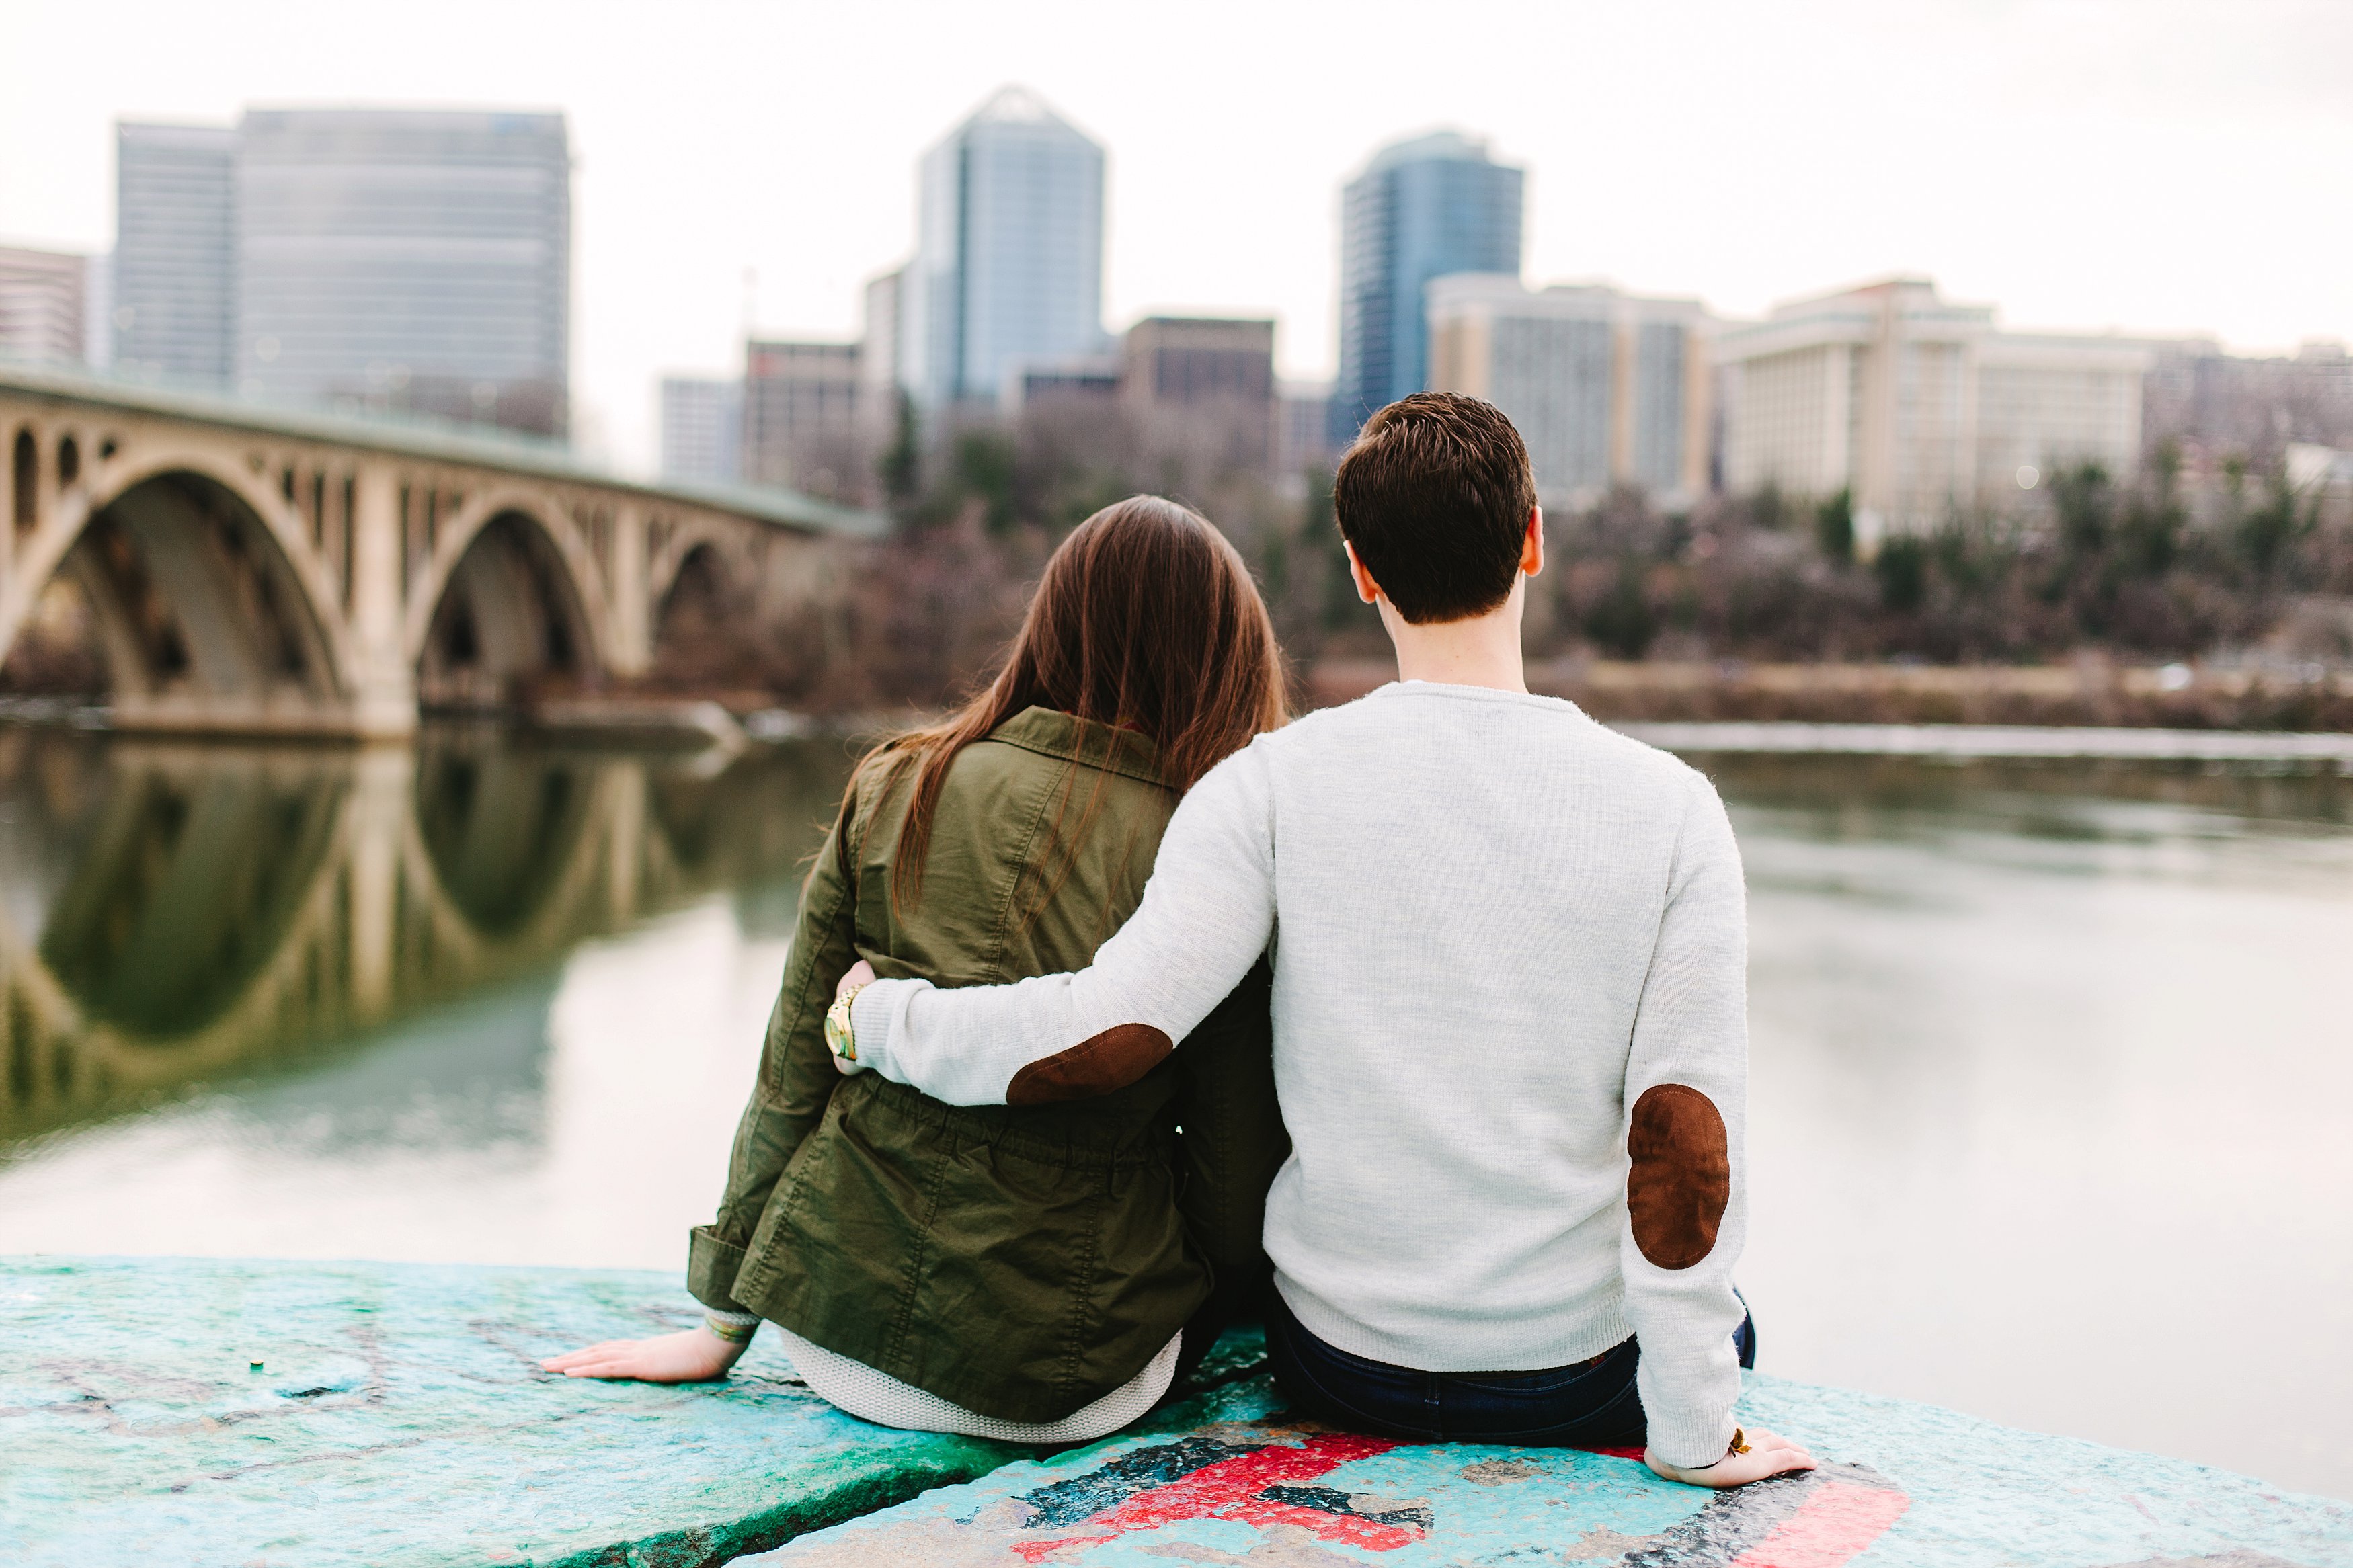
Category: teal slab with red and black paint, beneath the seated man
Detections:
[{"x1": 744, "y1": 1378, "x2": 2353, "y2": 1568}]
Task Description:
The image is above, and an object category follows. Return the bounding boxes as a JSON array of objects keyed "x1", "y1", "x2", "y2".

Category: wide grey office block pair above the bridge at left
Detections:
[{"x1": 111, "y1": 108, "x2": 572, "y2": 435}]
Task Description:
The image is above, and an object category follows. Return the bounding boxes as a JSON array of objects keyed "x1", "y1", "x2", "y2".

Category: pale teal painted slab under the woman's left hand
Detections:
[{"x1": 0, "y1": 1257, "x2": 1029, "y2": 1568}]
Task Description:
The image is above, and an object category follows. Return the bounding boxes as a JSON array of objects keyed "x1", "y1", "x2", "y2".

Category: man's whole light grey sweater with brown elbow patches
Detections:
[{"x1": 852, "y1": 682, "x2": 1749, "y2": 1464}]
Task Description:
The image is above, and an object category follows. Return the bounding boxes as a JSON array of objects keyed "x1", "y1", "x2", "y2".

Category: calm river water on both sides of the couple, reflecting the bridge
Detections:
[{"x1": 0, "y1": 729, "x2": 2353, "y2": 1497}]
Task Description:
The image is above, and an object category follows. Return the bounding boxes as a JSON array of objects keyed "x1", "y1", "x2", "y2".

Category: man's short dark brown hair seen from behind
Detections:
[{"x1": 1332, "y1": 393, "x2": 1537, "y2": 625}]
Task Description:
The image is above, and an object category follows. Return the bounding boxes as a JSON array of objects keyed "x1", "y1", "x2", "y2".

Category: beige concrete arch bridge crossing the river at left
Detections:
[{"x1": 0, "y1": 362, "x2": 885, "y2": 736}]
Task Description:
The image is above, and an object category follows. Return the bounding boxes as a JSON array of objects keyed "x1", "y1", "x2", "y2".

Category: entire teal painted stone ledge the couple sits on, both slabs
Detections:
[{"x1": 0, "y1": 1257, "x2": 2353, "y2": 1568}]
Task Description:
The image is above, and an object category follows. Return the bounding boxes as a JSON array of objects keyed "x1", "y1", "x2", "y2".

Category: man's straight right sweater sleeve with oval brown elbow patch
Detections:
[{"x1": 1619, "y1": 774, "x2": 1749, "y2": 1467}]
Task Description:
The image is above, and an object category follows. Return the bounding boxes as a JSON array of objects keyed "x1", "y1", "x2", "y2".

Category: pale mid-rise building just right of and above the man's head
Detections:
[{"x1": 1429, "y1": 273, "x2": 1711, "y2": 505}]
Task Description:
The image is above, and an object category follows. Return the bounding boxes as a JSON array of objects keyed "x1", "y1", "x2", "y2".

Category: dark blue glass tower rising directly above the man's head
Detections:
[{"x1": 1332, "y1": 132, "x2": 1525, "y2": 442}]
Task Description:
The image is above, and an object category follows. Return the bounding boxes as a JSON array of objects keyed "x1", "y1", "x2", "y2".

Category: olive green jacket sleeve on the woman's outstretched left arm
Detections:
[{"x1": 687, "y1": 785, "x2": 861, "y2": 1314}]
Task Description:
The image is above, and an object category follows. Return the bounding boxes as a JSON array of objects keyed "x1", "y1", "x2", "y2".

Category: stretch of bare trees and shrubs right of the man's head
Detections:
[{"x1": 1548, "y1": 452, "x2": 2353, "y2": 663}]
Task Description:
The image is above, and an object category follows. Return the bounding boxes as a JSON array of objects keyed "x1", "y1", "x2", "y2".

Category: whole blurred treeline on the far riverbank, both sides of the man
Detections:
[{"x1": 664, "y1": 405, "x2": 2353, "y2": 708}]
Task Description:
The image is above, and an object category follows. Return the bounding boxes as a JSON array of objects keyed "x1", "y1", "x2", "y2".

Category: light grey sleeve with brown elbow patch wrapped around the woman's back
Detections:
[{"x1": 852, "y1": 738, "x2": 1275, "y2": 1105}]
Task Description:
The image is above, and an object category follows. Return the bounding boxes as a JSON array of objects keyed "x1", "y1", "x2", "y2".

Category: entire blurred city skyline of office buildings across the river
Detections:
[{"x1": 0, "y1": 87, "x2": 2353, "y2": 542}]
